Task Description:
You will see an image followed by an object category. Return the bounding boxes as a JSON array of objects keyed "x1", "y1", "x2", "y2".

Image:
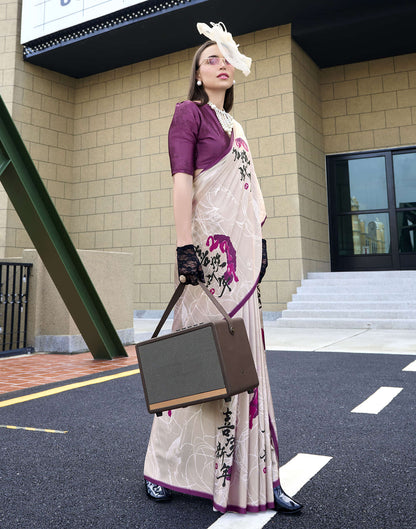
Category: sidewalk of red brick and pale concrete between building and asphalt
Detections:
[{"x1": 0, "y1": 318, "x2": 416, "y2": 394}]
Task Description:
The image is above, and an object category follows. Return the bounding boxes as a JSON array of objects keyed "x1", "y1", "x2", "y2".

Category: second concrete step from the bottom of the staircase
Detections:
[{"x1": 282, "y1": 307, "x2": 416, "y2": 321}]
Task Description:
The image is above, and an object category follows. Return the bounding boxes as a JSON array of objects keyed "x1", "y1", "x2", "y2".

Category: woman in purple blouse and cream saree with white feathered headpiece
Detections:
[{"x1": 144, "y1": 24, "x2": 302, "y2": 513}]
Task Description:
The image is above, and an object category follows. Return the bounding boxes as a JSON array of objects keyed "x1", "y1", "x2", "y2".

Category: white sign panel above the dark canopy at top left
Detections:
[{"x1": 20, "y1": 0, "x2": 147, "y2": 44}]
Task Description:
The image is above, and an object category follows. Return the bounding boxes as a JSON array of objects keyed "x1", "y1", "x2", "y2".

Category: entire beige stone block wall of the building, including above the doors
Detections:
[{"x1": 4, "y1": 10, "x2": 416, "y2": 311}]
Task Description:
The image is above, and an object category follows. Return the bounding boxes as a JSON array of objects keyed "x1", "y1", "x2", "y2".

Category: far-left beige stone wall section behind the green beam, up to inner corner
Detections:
[{"x1": 0, "y1": 0, "x2": 75, "y2": 257}]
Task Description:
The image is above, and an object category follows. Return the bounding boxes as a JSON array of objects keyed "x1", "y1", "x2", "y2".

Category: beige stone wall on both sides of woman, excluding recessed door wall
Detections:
[{"x1": 0, "y1": 13, "x2": 332, "y2": 310}]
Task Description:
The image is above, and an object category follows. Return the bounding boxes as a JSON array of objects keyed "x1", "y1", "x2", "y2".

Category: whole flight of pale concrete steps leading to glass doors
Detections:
[{"x1": 277, "y1": 270, "x2": 416, "y2": 329}]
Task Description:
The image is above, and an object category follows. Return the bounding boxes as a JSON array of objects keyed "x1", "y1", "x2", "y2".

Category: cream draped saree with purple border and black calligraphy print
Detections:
[{"x1": 144, "y1": 123, "x2": 279, "y2": 513}]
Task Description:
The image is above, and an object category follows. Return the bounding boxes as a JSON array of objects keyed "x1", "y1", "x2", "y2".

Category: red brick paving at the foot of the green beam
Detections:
[{"x1": 0, "y1": 345, "x2": 137, "y2": 393}]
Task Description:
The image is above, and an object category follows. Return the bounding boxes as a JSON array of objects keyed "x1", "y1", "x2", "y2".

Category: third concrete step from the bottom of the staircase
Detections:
[{"x1": 287, "y1": 297, "x2": 416, "y2": 311}]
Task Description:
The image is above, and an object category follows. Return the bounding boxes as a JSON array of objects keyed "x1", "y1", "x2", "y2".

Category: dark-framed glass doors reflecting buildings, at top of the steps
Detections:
[{"x1": 327, "y1": 150, "x2": 416, "y2": 271}]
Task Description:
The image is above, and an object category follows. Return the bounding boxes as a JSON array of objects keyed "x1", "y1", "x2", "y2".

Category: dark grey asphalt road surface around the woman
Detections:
[{"x1": 0, "y1": 350, "x2": 416, "y2": 529}]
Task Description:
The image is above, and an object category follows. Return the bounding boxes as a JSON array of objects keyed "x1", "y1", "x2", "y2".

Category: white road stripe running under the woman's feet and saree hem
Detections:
[{"x1": 208, "y1": 454, "x2": 332, "y2": 529}]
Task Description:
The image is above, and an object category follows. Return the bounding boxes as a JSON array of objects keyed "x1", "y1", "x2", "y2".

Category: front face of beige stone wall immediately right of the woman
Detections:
[{"x1": 234, "y1": 25, "x2": 302, "y2": 311}]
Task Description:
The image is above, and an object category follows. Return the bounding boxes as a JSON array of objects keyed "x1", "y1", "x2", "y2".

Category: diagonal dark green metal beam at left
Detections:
[{"x1": 0, "y1": 96, "x2": 127, "y2": 359}]
